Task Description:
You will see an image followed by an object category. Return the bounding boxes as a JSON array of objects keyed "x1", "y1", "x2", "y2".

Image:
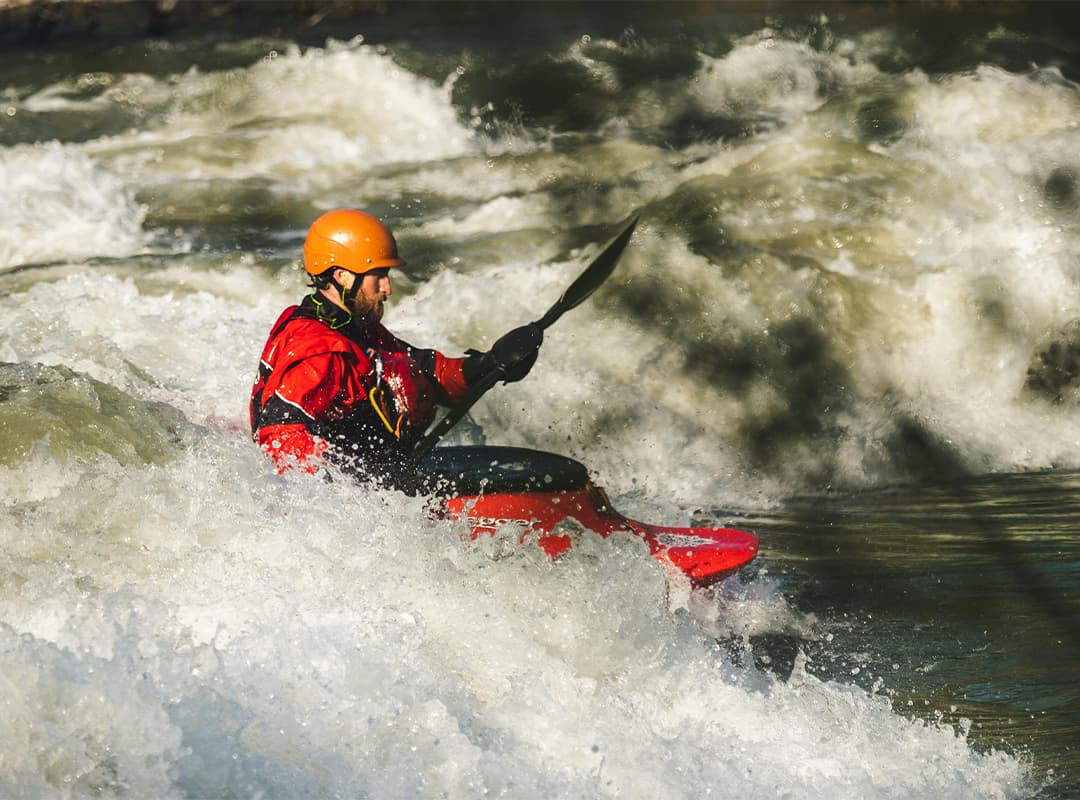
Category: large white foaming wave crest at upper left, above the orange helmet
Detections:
[{"x1": 91, "y1": 39, "x2": 475, "y2": 190}]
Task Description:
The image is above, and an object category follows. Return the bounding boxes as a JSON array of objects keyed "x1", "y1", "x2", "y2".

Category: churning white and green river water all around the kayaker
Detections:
[{"x1": 0, "y1": 3, "x2": 1080, "y2": 799}]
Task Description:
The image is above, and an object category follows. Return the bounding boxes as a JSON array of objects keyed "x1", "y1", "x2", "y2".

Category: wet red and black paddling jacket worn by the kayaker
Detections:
[{"x1": 251, "y1": 294, "x2": 469, "y2": 484}]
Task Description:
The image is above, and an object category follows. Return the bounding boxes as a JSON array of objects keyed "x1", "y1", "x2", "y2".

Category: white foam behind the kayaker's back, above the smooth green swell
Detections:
[{"x1": 0, "y1": 265, "x2": 287, "y2": 430}]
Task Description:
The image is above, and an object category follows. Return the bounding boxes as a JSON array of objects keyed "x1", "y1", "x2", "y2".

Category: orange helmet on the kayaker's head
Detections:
[{"x1": 303, "y1": 208, "x2": 405, "y2": 275}]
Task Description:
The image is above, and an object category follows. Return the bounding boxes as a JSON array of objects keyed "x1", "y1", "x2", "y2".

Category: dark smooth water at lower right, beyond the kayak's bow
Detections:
[{"x1": 725, "y1": 473, "x2": 1080, "y2": 797}]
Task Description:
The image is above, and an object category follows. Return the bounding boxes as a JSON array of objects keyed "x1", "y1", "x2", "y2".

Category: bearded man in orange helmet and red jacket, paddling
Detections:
[{"x1": 251, "y1": 208, "x2": 543, "y2": 490}]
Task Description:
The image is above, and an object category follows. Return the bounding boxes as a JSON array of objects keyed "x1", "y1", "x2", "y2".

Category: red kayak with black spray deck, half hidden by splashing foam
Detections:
[{"x1": 421, "y1": 447, "x2": 758, "y2": 586}]
